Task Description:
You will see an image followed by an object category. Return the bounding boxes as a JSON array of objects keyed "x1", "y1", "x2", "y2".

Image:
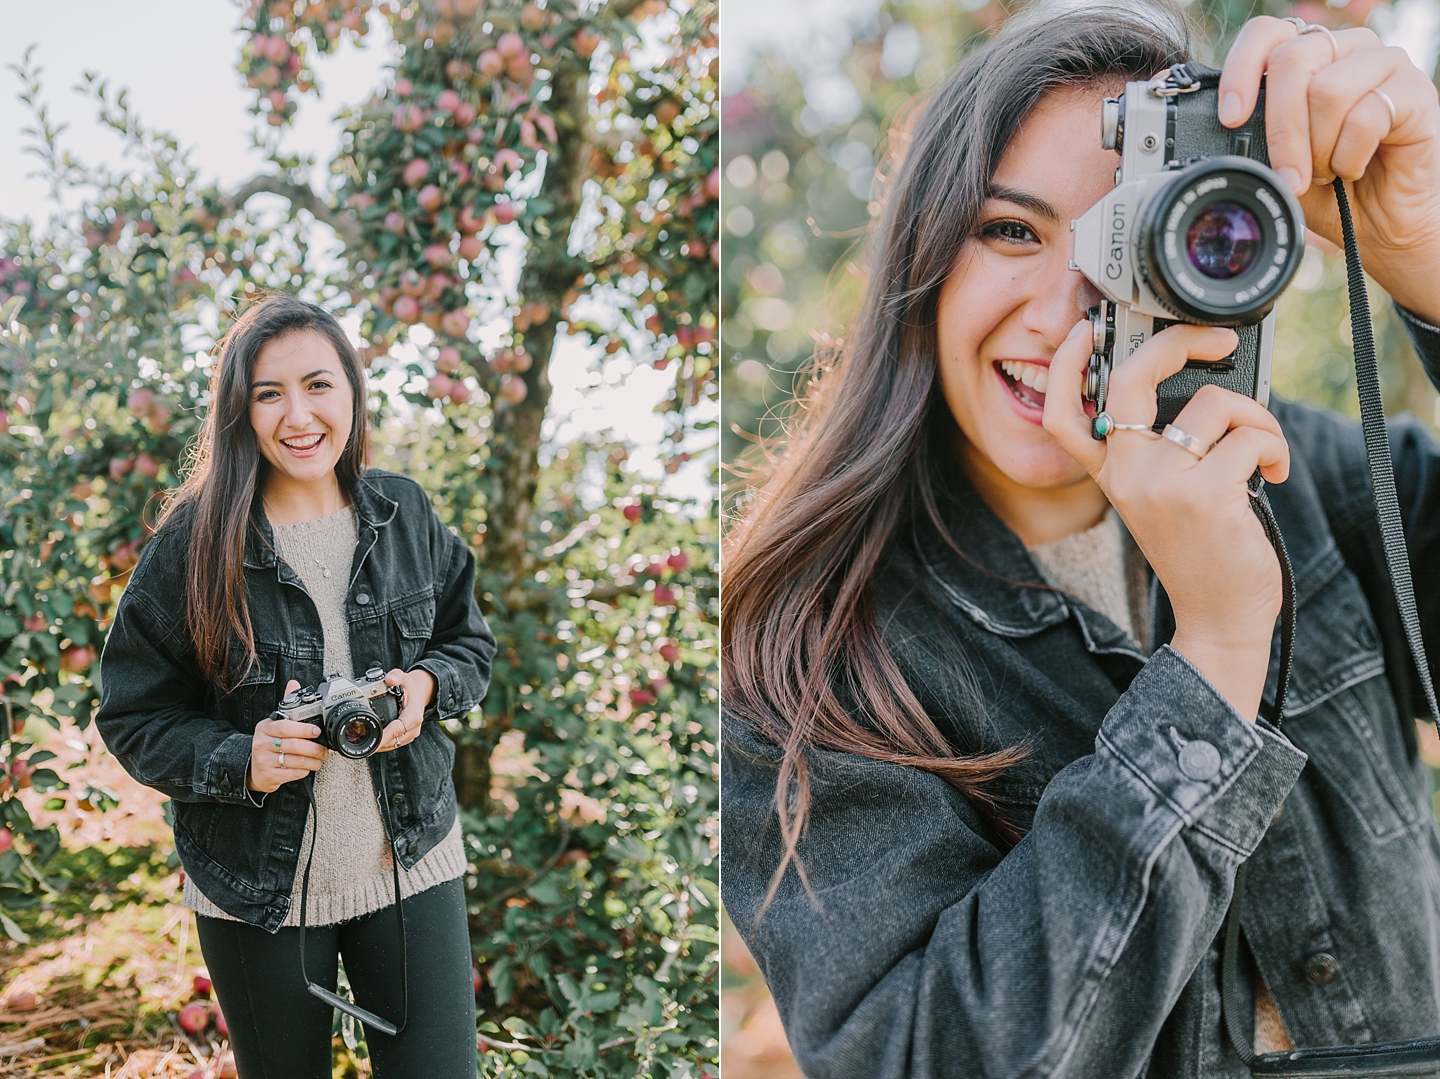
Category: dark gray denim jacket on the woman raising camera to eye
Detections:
[{"x1": 721, "y1": 306, "x2": 1440, "y2": 1079}]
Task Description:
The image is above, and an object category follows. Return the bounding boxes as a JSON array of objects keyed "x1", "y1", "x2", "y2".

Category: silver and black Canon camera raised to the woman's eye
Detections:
[{"x1": 1070, "y1": 62, "x2": 1305, "y2": 426}]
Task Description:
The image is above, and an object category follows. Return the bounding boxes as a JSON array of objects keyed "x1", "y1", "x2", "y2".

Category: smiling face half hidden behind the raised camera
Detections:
[{"x1": 937, "y1": 88, "x2": 1119, "y2": 488}]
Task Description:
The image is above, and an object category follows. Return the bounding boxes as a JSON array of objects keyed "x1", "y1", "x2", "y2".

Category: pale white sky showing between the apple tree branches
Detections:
[{"x1": 0, "y1": 0, "x2": 708, "y2": 500}]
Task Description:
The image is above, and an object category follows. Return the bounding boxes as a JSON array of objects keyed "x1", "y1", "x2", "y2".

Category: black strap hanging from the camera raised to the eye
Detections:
[{"x1": 1220, "y1": 177, "x2": 1440, "y2": 1079}]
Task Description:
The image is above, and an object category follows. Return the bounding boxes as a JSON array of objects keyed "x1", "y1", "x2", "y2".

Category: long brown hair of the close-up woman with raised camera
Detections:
[{"x1": 721, "y1": 7, "x2": 1188, "y2": 902}]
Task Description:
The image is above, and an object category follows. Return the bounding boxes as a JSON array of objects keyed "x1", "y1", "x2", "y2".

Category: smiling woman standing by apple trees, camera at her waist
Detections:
[{"x1": 96, "y1": 295, "x2": 495, "y2": 1079}]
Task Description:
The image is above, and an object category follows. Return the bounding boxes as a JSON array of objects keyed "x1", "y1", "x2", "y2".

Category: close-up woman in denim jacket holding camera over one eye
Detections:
[{"x1": 723, "y1": 9, "x2": 1440, "y2": 1079}]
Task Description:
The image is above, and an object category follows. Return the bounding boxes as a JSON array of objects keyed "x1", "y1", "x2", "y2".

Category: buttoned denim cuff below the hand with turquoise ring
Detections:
[{"x1": 1096, "y1": 645, "x2": 1306, "y2": 857}]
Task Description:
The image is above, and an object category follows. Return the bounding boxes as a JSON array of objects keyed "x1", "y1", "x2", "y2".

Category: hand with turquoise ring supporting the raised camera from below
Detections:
[{"x1": 1045, "y1": 321, "x2": 1290, "y2": 720}]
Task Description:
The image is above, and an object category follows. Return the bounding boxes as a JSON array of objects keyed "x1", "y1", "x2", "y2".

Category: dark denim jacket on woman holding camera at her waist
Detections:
[{"x1": 95, "y1": 470, "x2": 495, "y2": 932}]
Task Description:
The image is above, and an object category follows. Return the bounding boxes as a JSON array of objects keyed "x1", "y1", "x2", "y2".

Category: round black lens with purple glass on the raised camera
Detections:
[{"x1": 1133, "y1": 156, "x2": 1305, "y2": 326}]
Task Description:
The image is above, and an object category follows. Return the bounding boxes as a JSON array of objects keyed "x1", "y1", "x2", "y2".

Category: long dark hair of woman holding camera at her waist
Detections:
[{"x1": 160, "y1": 292, "x2": 370, "y2": 686}]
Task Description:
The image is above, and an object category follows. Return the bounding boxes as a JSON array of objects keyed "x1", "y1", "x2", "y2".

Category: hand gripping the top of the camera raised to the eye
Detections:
[{"x1": 1220, "y1": 16, "x2": 1440, "y2": 321}]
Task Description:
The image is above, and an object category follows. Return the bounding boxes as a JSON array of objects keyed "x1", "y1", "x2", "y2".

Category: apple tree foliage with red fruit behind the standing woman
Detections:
[{"x1": 0, "y1": 0, "x2": 719, "y2": 1076}]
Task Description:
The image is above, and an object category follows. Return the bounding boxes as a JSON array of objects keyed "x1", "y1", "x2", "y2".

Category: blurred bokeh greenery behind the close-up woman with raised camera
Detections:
[{"x1": 720, "y1": 0, "x2": 1440, "y2": 1079}]
